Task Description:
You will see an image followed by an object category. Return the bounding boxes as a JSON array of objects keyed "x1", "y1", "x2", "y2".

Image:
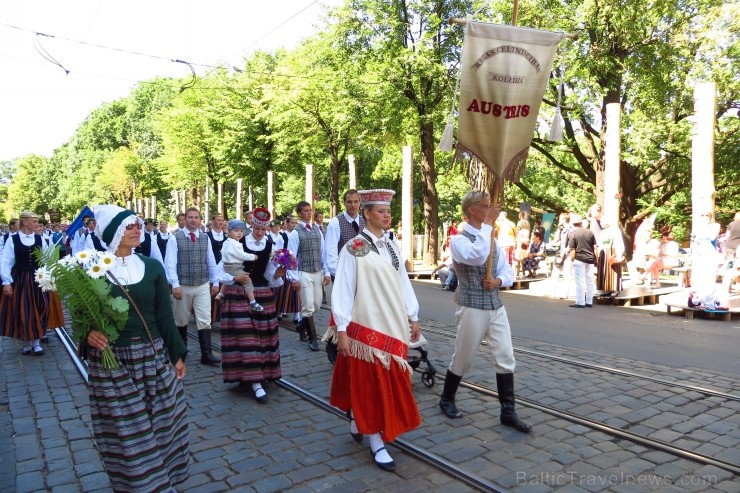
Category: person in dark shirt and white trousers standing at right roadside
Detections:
[{"x1": 568, "y1": 215, "x2": 596, "y2": 308}]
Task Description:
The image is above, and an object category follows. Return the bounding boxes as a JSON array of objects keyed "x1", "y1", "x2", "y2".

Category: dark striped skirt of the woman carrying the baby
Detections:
[{"x1": 221, "y1": 284, "x2": 281, "y2": 383}]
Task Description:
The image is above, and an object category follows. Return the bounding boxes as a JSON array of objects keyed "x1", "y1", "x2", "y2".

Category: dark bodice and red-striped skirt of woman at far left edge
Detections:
[{"x1": 0, "y1": 269, "x2": 49, "y2": 342}]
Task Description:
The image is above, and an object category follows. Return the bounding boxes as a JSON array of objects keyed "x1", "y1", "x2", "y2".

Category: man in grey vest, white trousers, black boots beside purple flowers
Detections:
[{"x1": 295, "y1": 201, "x2": 331, "y2": 351}]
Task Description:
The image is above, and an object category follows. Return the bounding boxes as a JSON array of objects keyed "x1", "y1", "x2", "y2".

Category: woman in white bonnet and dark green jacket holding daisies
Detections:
[{"x1": 87, "y1": 205, "x2": 189, "y2": 492}]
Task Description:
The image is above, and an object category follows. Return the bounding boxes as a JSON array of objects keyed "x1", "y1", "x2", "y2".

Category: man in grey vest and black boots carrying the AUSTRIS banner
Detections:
[{"x1": 439, "y1": 191, "x2": 532, "y2": 433}]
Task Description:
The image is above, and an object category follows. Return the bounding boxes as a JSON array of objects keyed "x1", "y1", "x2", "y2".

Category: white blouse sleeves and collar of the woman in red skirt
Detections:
[{"x1": 331, "y1": 228, "x2": 419, "y2": 332}]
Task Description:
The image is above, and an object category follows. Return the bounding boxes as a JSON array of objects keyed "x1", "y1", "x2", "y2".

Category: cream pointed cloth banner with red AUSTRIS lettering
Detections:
[{"x1": 458, "y1": 21, "x2": 565, "y2": 180}]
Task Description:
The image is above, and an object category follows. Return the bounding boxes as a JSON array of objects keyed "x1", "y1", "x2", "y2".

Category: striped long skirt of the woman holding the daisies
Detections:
[{"x1": 88, "y1": 338, "x2": 189, "y2": 492}]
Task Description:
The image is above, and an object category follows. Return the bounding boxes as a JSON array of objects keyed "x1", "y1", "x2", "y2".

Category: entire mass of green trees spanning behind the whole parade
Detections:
[{"x1": 0, "y1": 0, "x2": 740, "y2": 262}]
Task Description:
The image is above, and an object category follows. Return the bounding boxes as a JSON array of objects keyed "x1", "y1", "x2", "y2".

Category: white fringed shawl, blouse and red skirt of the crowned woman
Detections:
[{"x1": 324, "y1": 229, "x2": 421, "y2": 441}]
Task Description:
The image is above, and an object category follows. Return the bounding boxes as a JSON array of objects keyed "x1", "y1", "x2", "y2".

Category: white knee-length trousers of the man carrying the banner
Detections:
[{"x1": 449, "y1": 306, "x2": 516, "y2": 376}]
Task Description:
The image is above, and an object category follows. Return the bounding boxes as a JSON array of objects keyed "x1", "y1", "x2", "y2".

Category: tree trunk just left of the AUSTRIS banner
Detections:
[{"x1": 420, "y1": 119, "x2": 439, "y2": 265}]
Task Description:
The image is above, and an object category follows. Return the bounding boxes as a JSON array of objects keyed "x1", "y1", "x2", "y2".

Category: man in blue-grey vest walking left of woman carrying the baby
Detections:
[{"x1": 164, "y1": 207, "x2": 221, "y2": 366}]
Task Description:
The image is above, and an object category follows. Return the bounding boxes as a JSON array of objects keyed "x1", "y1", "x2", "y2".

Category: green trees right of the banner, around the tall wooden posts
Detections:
[{"x1": 494, "y1": 0, "x2": 740, "y2": 242}]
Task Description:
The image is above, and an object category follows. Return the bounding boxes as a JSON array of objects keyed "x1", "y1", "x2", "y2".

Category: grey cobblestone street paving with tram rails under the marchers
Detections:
[{"x1": 0, "y1": 302, "x2": 740, "y2": 493}]
